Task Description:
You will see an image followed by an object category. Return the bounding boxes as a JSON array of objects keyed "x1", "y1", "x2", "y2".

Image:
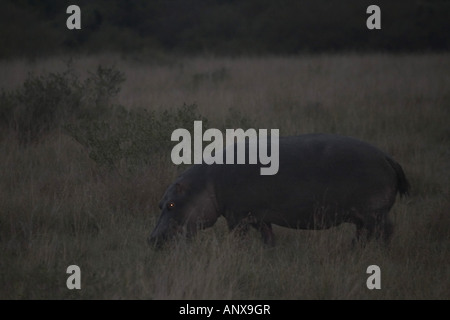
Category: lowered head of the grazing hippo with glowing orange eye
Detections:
[{"x1": 148, "y1": 171, "x2": 219, "y2": 245}]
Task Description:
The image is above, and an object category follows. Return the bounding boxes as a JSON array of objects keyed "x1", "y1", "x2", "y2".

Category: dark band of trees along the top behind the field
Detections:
[{"x1": 0, "y1": 0, "x2": 450, "y2": 58}]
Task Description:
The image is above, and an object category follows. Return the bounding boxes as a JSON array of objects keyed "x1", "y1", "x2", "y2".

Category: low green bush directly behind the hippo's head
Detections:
[{"x1": 66, "y1": 104, "x2": 208, "y2": 173}]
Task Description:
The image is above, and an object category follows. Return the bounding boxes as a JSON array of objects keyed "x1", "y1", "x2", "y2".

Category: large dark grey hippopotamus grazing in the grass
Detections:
[{"x1": 148, "y1": 134, "x2": 409, "y2": 244}]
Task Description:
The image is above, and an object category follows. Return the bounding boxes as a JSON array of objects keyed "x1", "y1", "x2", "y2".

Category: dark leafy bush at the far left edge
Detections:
[{"x1": 0, "y1": 63, "x2": 125, "y2": 143}]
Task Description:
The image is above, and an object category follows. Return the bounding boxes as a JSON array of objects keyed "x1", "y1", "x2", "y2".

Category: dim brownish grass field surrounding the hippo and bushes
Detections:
[{"x1": 0, "y1": 54, "x2": 450, "y2": 299}]
